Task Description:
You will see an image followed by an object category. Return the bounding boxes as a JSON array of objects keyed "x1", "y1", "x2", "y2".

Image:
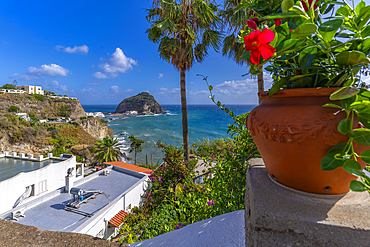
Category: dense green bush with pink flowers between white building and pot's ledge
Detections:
[{"x1": 120, "y1": 111, "x2": 260, "y2": 242}]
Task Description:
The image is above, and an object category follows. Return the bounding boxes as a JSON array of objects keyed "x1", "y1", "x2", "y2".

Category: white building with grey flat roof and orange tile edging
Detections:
[{"x1": 0, "y1": 154, "x2": 151, "y2": 239}]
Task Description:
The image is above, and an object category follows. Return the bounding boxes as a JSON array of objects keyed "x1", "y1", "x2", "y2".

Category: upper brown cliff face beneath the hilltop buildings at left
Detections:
[{"x1": 0, "y1": 93, "x2": 86, "y2": 119}]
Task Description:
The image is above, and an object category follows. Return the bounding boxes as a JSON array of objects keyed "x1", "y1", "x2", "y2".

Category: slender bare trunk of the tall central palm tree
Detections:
[{"x1": 180, "y1": 69, "x2": 189, "y2": 162}]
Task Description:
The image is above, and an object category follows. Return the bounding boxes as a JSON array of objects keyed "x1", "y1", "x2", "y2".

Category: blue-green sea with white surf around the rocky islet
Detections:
[{"x1": 82, "y1": 105, "x2": 256, "y2": 164}]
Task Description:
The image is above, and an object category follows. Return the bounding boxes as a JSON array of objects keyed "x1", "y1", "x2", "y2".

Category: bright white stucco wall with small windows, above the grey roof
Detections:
[{"x1": 0, "y1": 156, "x2": 76, "y2": 214}]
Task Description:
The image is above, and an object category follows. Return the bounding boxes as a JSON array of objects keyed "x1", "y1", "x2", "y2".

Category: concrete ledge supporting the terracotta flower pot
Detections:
[{"x1": 245, "y1": 159, "x2": 370, "y2": 246}]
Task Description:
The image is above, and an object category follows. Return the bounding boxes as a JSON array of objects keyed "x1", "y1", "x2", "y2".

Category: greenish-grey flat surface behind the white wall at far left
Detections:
[{"x1": 0, "y1": 157, "x2": 62, "y2": 182}]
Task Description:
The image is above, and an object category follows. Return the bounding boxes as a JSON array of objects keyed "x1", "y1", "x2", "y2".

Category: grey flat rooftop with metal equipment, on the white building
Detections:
[{"x1": 8, "y1": 169, "x2": 144, "y2": 232}]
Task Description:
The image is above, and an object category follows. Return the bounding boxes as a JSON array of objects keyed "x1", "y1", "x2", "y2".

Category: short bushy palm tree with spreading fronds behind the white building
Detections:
[{"x1": 93, "y1": 136, "x2": 123, "y2": 164}]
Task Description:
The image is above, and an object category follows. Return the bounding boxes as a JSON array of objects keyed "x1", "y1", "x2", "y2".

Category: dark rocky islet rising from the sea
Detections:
[{"x1": 116, "y1": 92, "x2": 166, "y2": 115}]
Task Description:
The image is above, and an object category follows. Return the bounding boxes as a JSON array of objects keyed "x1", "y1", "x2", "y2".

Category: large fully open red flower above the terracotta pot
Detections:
[{"x1": 244, "y1": 28, "x2": 276, "y2": 65}]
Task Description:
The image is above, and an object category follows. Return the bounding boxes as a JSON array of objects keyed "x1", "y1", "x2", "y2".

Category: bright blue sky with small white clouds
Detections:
[{"x1": 0, "y1": 0, "x2": 271, "y2": 104}]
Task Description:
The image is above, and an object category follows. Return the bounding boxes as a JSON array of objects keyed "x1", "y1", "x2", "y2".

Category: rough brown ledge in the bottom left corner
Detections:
[{"x1": 0, "y1": 219, "x2": 128, "y2": 247}]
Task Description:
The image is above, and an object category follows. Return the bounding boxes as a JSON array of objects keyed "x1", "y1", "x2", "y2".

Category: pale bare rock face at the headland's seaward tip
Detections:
[{"x1": 78, "y1": 118, "x2": 113, "y2": 139}]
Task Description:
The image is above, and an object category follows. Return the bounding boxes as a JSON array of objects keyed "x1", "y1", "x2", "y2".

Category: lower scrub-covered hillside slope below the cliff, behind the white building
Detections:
[{"x1": 0, "y1": 113, "x2": 111, "y2": 158}]
